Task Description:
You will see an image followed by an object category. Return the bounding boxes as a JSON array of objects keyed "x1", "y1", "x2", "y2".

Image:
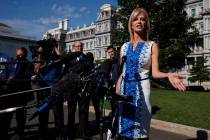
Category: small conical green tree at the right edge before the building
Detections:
[{"x1": 188, "y1": 57, "x2": 210, "y2": 86}]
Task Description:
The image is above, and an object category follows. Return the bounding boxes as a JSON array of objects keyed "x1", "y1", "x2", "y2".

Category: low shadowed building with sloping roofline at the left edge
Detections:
[{"x1": 0, "y1": 23, "x2": 36, "y2": 57}]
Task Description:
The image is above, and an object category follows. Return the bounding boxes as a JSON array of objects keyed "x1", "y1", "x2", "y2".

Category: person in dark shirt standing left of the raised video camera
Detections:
[{"x1": 10, "y1": 47, "x2": 34, "y2": 139}]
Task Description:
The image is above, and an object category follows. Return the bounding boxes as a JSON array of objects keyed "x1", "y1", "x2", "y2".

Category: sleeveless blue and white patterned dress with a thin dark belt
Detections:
[{"x1": 119, "y1": 41, "x2": 153, "y2": 139}]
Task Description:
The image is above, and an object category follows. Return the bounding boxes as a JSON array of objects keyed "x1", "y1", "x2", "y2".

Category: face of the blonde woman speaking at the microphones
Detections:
[{"x1": 131, "y1": 12, "x2": 146, "y2": 33}]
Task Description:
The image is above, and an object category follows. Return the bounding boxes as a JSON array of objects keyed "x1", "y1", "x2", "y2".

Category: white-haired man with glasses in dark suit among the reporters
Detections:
[{"x1": 52, "y1": 41, "x2": 94, "y2": 140}]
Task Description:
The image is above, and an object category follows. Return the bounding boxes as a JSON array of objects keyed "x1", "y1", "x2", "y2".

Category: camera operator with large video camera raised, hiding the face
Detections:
[{"x1": 31, "y1": 39, "x2": 64, "y2": 139}]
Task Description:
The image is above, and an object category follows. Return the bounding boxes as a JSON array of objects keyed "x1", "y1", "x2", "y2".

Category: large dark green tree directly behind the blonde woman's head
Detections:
[{"x1": 113, "y1": 0, "x2": 198, "y2": 71}]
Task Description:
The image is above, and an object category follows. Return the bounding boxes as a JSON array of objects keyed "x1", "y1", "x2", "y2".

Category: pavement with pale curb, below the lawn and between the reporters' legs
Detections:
[{"x1": 9, "y1": 104, "x2": 207, "y2": 140}]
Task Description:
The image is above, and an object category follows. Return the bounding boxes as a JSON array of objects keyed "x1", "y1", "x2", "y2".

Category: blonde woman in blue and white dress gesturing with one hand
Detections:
[{"x1": 116, "y1": 8, "x2": 185, "y2": 139}]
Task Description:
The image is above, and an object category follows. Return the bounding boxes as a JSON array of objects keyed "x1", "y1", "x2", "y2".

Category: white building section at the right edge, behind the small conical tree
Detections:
[{"x1": 183, "y1": 0, "x2": 210, "y2": 89}]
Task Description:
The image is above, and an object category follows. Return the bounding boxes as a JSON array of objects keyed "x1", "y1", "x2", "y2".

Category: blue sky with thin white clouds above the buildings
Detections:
[{"x1": 0, "y1": 0, "x2": 117, "y2": 40}]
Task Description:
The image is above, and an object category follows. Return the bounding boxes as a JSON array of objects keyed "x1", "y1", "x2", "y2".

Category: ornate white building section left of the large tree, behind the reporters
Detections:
[{"x1": 44, "y1": 4, "x2": 117, "y2": 60}]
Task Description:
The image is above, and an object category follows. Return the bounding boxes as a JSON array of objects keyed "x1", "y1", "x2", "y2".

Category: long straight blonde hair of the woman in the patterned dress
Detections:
[{"x1": 128, "y1": 8, "x2": 150, "y2": 42}]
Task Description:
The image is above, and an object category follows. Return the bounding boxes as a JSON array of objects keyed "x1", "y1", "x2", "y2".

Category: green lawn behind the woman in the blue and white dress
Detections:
[{"x1": 101, "y1": 89, "x2": 210, "y2": 130}]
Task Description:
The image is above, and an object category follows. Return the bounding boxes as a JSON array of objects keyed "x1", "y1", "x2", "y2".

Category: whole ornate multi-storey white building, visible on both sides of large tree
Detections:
[{"x1": 45, "y1": 0, "x2": 210, "y2": 86}]
